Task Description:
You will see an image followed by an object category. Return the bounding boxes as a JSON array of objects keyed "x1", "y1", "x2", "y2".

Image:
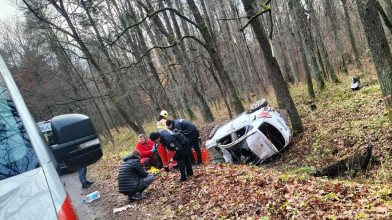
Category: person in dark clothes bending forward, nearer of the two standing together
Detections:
[{"x1": 150, "y1": 129, "x2": 193, "y2": 182}]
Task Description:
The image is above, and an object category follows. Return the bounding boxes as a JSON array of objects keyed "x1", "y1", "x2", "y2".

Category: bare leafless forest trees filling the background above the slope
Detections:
[{"x1": 0, "y1": 0, "x2": 392, "y2": 140}]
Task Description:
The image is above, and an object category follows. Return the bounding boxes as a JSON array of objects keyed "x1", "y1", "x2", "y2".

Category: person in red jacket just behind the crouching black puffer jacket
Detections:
[{"x1": 136, "y1": 134, "x2": 157, "y2": 169}]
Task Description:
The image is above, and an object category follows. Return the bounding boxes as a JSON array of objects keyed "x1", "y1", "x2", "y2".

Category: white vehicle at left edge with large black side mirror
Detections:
[{"x1": 0, "y1": 56, "x2": 102, "y2": 220}]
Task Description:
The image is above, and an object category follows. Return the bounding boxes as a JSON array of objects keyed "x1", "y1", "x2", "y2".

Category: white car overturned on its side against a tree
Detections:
[{"x1": 206, "y1": 99, "x2": 291, "y2": 164}]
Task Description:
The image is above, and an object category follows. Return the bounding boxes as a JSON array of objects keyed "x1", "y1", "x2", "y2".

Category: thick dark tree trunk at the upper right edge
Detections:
[{"x1": 356, "y1": 0, "x2": 392, "y2": 118}]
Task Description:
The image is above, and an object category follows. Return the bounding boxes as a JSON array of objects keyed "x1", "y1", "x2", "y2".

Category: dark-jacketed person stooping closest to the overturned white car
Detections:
[{"x1": 166, "y1": 119, "x2": 202, "y2": 164}]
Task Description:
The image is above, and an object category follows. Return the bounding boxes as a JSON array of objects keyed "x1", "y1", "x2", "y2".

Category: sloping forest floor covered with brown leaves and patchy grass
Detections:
[{"x1": 86, "y1": 64, "x2": 392, "y2": 220}]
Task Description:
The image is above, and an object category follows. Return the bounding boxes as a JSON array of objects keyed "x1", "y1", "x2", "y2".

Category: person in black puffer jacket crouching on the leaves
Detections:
[{"x1": 118, "y1": 150, "x2": 154, "y2": 200}]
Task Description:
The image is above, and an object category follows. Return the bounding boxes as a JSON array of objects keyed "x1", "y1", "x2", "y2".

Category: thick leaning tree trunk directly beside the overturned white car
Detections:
[{"x1": 242, "y1": 0, "x2": 304, "y2": 133}]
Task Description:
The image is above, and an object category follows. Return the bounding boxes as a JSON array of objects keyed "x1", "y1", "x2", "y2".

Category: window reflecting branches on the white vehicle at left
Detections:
[{"x1": 0, "y1": 72, "x2": 39, "y2": 180}]
